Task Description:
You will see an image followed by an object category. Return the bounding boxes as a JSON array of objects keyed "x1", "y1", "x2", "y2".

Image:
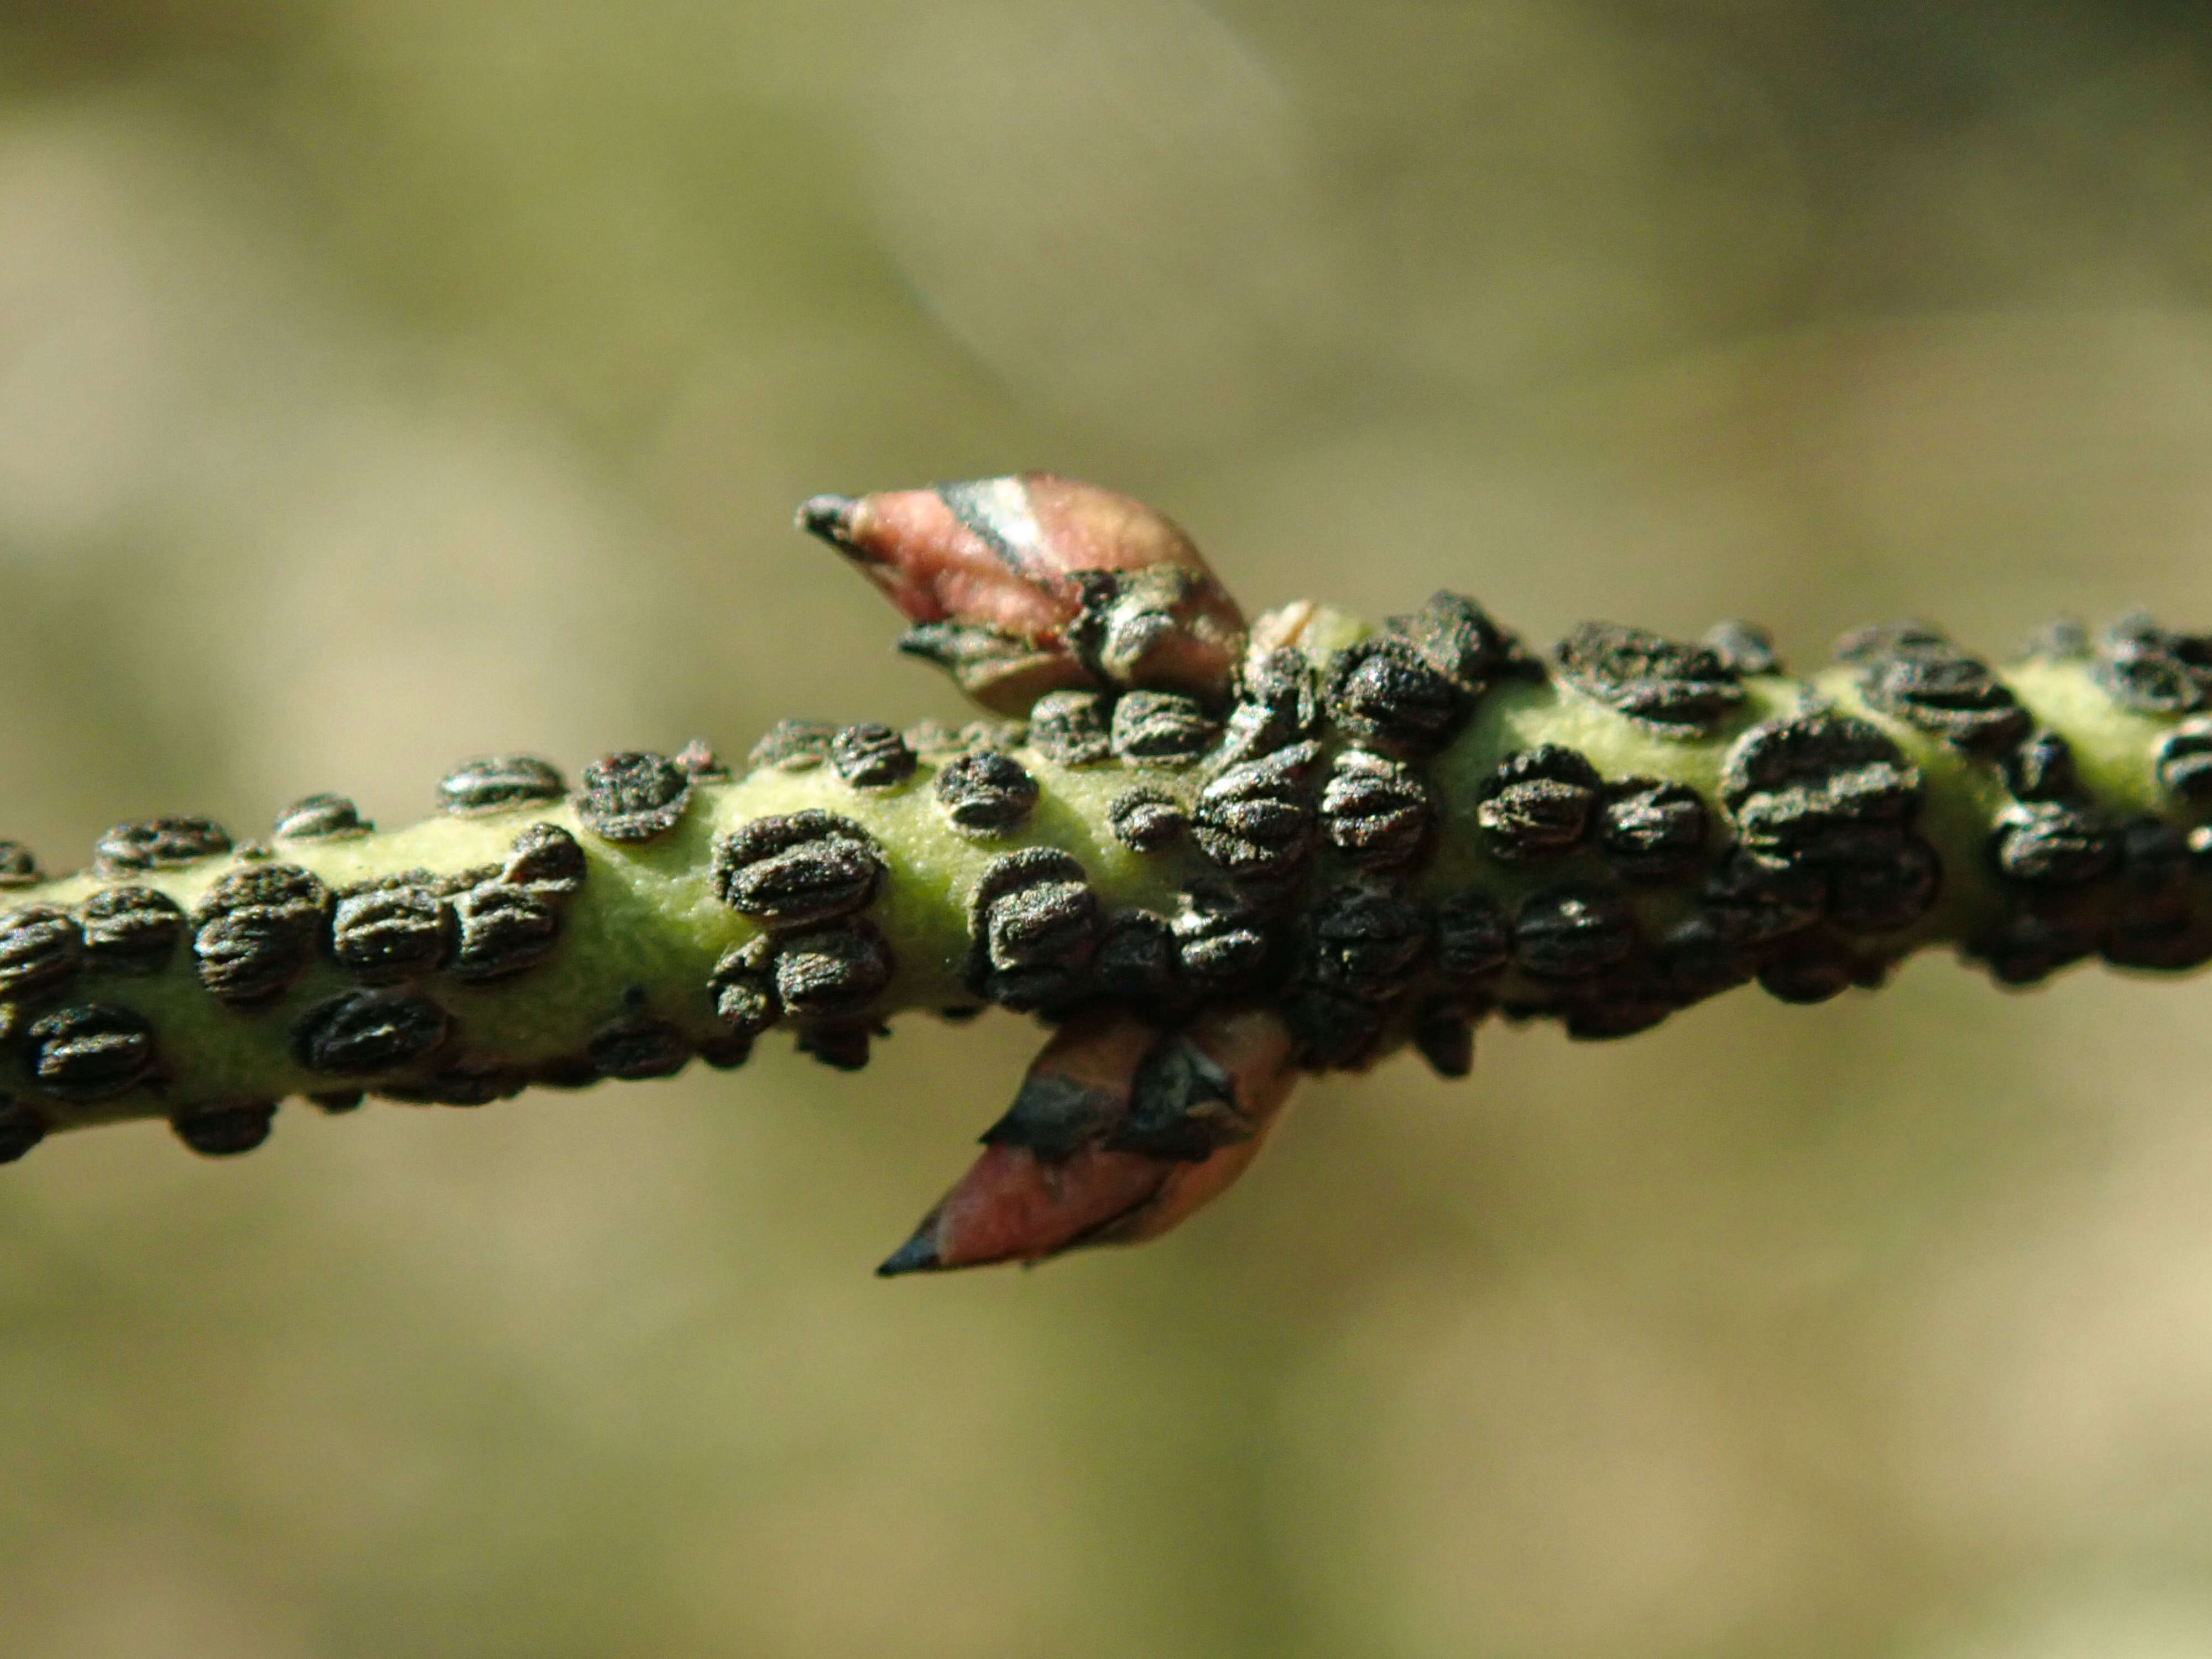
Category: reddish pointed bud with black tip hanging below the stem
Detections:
[{"x1": 876, "y1": 1009, "x2": 1296, "y2": 1276}]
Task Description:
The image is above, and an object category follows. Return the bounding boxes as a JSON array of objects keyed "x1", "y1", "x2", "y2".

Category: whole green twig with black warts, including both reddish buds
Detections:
[{"x1": 0, "y1": 476, "x2": 2212, "y2": 1272}]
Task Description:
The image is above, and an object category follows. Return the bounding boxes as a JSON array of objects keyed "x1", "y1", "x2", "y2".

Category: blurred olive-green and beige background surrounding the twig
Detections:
[{"x1": 0, "y1": 0, "x2": 2212, "y2": 1659}]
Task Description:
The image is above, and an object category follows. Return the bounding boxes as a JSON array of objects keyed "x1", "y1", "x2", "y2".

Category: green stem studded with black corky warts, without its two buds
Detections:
[{"x1": 0, "y1": 613, "x2": 2212, "y2": 1155}]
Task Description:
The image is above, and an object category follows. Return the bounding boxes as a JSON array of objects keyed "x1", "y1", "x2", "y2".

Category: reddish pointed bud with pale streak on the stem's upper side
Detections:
[{"x1": 799, "y1": 473, "x2": 1243, "y2": 714}]
